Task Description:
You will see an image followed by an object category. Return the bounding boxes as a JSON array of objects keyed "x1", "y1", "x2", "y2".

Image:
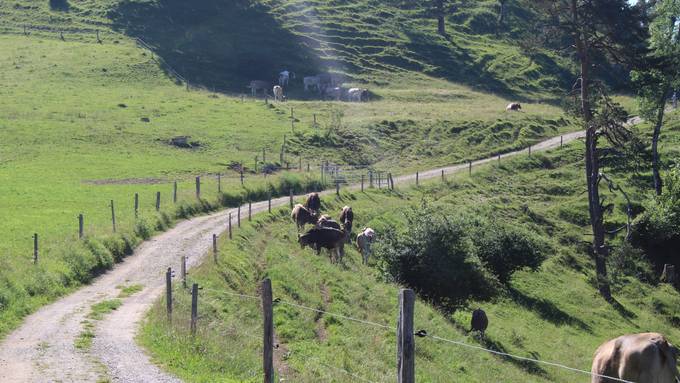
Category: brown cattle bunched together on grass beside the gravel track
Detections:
[{"x1": 290, "y1": 193, "x2": 375, "y2": 264}]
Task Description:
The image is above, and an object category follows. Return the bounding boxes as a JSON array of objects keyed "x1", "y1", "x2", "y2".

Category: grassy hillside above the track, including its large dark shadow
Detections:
[{"x1": 0, "y1": 0, "x2": 576, "y2": 335}]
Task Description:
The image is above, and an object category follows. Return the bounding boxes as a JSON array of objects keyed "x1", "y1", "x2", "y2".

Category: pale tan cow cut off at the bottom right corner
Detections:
[{"x1": 591, "y1": 332, "x2": 678, "y2": 383}]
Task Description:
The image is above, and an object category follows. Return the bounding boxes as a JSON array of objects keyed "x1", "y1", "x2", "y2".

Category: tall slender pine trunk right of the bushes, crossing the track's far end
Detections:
[{"x1": 571, "y1": 0, "x2": 611, "y2": 301}]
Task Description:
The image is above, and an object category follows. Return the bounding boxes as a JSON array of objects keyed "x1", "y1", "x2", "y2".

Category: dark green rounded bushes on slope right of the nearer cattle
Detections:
[{"x1": 376, "y1": 207, "x2": 548, "y2": 308}]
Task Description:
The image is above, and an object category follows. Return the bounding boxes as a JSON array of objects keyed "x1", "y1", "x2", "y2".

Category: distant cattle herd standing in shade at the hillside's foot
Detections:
[{"x1": 248, "y1": 70, "x2": 369, "y2": 102}]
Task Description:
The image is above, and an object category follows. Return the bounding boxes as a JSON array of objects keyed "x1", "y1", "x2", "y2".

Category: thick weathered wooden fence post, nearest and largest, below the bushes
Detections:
[{"x1": 397, "y1": 289, "x2": 415, "y2": 383}]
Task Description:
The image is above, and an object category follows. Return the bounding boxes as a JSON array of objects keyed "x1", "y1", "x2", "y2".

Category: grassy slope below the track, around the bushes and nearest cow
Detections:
[{"x1": 140, "y1": 115, "x2": 680, "y2": 382}]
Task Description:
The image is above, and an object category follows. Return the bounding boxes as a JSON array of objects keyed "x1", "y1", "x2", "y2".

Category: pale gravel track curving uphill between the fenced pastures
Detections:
[{"x1": 0, "y1": 127, "x2": 596, "y2": 383}]
